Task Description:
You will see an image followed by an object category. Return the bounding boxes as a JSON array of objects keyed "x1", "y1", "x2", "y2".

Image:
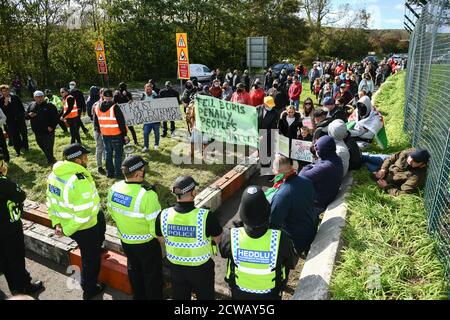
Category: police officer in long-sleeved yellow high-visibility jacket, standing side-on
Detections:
[{"x1": 47, "y1": 143, "x2": 106, "y2": 300}]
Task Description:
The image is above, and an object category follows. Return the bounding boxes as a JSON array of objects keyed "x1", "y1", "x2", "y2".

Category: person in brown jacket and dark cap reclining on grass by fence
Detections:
[{"x1": 362, "y1": 148, "x2": 430, "y2": 196}]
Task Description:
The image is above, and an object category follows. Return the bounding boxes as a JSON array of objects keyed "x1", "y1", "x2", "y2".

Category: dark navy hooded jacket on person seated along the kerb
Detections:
[{"x1": 299, "y1": 136, "x2": 343, "y2": 213}]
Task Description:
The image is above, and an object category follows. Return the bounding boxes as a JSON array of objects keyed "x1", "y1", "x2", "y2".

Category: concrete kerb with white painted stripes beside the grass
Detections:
[{"x1": 292, "y1": 173, "x2": 353, "y2": 300}]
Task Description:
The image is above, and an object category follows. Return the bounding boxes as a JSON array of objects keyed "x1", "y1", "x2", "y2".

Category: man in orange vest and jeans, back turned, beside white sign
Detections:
[{"x1": 94, "y1": 89, "x2": 130, "y2": 179}]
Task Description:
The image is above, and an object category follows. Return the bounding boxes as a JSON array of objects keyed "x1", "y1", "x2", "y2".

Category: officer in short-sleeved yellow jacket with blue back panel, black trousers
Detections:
[{"x1": 108, "y1": 155, "x2": 163, "y2": 300}]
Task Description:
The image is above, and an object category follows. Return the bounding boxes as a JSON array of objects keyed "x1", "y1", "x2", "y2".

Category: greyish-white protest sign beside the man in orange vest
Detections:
[{"x1": 119, "y1": 98, "x2": 181, "y2": 126}]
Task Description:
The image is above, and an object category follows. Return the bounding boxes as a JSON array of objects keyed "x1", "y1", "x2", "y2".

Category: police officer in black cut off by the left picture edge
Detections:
[{"x1": 0, "y1": 149, "x2": 44, "y2": 295}]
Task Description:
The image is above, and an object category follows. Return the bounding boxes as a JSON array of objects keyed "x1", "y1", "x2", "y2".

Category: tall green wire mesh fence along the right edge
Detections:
[{"x1": 404, "y1": 0, "x2": 450, "y2": 276}]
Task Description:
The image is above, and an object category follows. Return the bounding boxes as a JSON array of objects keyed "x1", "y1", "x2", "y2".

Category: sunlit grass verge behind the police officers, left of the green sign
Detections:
[{"x1": 8, "y1": 115, "x2": 233, "y2": 222}]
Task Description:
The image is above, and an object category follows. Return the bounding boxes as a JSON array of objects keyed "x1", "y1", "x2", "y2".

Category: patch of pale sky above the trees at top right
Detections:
[{"x1": 332, "y1": 0, "x2": 405, "y2": 29}]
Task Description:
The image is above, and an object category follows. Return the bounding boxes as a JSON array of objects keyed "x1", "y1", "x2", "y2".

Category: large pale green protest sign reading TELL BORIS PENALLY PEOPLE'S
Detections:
[{"x1": 195, "y1": 95, "x2": 259, "y2": 148}]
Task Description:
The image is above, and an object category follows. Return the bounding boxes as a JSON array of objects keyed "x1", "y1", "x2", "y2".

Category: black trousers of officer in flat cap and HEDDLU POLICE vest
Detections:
[{"x1": 170, "y1": 259, "x2": 215, "y2": 300}]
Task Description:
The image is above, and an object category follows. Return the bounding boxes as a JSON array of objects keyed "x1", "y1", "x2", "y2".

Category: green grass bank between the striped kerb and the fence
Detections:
[{"x1": 331, "y1": 73, "x2": 448, "y2": 300}]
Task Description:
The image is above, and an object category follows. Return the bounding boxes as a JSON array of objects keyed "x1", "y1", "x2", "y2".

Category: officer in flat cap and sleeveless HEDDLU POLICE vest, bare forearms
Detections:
[{"x1": 156, "y1": 176, "x2": 222, "y2": 300}]
